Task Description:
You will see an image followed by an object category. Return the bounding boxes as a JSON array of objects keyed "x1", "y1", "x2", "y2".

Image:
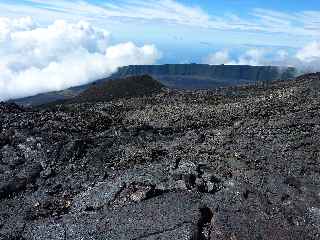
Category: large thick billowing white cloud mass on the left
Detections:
[{"x1": 0, "y1": 18, "x2": 161, "y2": 100}]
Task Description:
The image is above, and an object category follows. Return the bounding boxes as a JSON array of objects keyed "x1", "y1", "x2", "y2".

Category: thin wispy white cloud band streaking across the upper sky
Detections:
[{"x1": 0, "y1": 0, "x2": 320, "y2": 36}]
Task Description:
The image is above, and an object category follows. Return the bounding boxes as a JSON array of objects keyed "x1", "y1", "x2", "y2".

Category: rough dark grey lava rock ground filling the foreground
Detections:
[{"x1": 0, "y1": 74, "x2": 320, "y2": 240}]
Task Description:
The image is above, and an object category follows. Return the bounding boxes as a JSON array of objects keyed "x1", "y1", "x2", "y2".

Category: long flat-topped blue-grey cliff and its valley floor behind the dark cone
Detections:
[{"x1": 111, "y1": 64, "x2": 296, "y2": 89}]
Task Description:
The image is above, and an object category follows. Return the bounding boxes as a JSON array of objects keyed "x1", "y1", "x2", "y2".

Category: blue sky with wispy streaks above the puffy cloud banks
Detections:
[{"x1": 0, "y1": 0, "x2": 320, "y2": 63}]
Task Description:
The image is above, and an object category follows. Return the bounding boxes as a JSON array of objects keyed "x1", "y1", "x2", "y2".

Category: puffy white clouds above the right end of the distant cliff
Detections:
[{"x1": 203, "y1": 41, "x2": 320, "y2": 72}]
